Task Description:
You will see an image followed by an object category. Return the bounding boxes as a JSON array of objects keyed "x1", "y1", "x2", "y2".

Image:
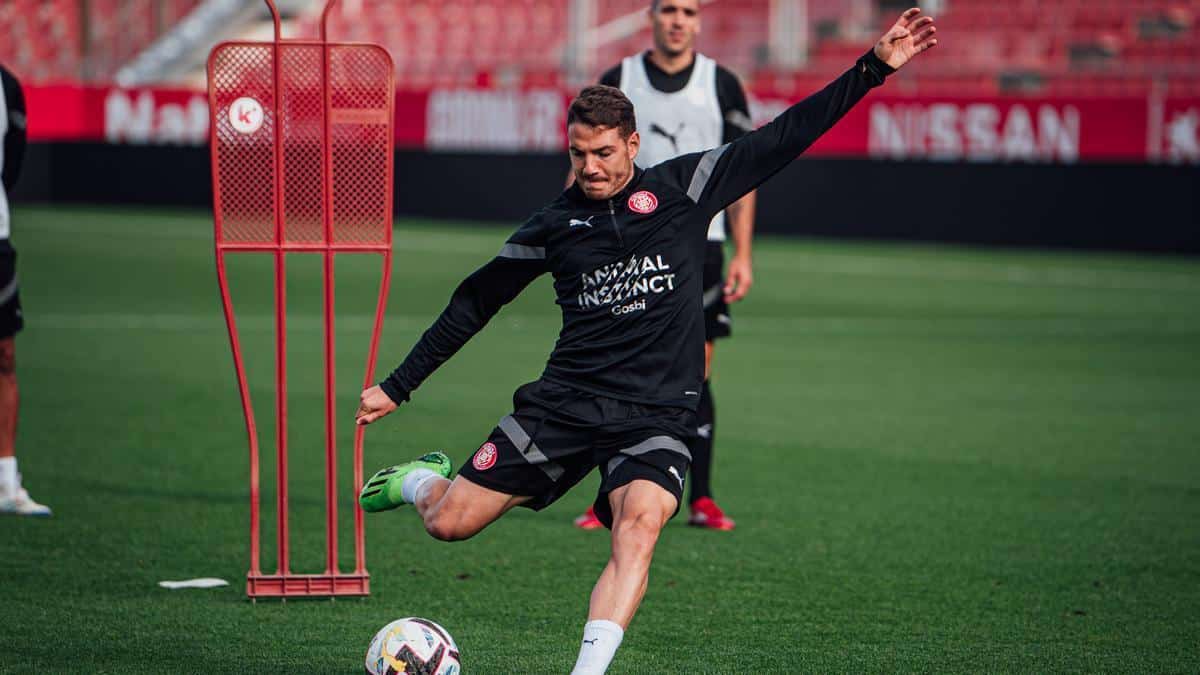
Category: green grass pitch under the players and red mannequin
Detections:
[{"x1": 0, "y1": 207, "x2": 1200, "y2": 675}]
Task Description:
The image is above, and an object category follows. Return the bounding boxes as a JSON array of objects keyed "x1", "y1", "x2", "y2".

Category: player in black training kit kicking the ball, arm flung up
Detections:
[{"x1": 356, "y1": 8, "x2": 937, "y2": 675}]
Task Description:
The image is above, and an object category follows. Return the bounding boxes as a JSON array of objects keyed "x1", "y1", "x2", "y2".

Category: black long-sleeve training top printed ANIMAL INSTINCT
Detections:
[{"x1": 380, "y1": 52, "x2": 893, "y2": 410}]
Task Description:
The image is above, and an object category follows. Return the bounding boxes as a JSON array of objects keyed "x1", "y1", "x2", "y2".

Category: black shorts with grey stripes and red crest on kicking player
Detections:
[{"x1": 458, "y1": 380, "x2": 696, "y2": 528}]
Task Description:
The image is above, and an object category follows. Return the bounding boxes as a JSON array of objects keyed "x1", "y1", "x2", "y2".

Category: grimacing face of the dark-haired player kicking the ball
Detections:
[{"x1": 566, "y1": 123, "x2": 641, "y2": 199}]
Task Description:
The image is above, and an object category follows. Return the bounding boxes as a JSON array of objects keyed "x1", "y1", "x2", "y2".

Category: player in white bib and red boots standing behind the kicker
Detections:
[{"x1": 575, "y1": 0, "x2": 755, "y2": 530}]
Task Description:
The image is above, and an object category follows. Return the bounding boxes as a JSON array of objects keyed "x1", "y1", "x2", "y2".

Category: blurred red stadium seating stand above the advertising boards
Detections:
[{"x1": 0, "y1": 0, "x2": 1200, "y2": 96}]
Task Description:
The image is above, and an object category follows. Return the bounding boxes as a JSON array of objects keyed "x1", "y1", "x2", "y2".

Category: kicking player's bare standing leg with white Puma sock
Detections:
[{"x1": 571, "y1": 480, "x2": 677, "y2": 675}]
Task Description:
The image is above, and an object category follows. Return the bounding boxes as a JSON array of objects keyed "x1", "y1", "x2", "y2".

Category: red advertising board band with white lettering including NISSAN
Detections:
[{"x1": 26, "y1": 85, "x2": 1200, "y2": 163}]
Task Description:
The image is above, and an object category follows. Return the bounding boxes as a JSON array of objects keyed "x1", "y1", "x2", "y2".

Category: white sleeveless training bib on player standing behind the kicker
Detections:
[{"x1": 620, "y1": 53, "x2": 725, "y2": 241}]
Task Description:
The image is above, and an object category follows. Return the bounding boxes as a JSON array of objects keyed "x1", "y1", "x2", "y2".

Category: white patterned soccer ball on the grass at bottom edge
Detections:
[{"x1": 366, "y1": 616, "x2": 462, "y2": 675}]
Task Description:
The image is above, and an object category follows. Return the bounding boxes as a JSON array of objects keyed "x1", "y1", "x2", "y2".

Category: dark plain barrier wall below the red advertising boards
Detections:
[{"x1": 13, "y1": 144, "x2": 1200, "y2": 255}]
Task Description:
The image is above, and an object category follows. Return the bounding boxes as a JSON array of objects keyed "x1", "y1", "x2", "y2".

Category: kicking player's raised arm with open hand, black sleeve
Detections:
[{"x1": 660, "y1": 7, "x2": 937, "y2": 220}]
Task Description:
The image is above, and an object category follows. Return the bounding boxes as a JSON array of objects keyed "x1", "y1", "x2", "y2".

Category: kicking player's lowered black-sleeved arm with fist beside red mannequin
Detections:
[{"x1": 354, "y1": 243, "x2": 545, "y2": 425}]
